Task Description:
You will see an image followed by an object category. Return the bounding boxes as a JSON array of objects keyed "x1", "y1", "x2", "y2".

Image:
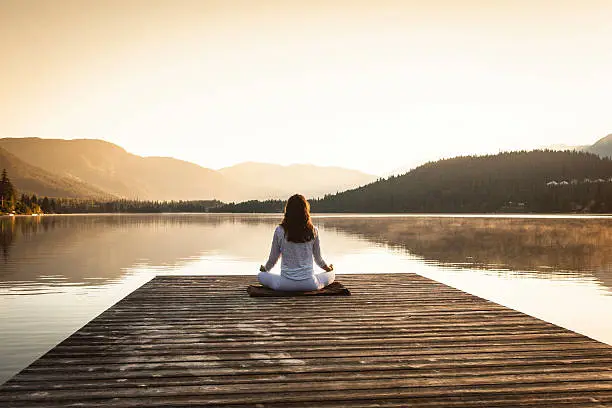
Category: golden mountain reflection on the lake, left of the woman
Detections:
[{"x1": 0, "y1": 215, "x2": 278, "y2": 286}]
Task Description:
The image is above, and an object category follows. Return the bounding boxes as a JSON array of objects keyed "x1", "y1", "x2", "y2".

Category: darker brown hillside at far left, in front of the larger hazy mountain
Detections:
[{"x1": 0, "y1": 147, "x2": 114, "y2": 199}]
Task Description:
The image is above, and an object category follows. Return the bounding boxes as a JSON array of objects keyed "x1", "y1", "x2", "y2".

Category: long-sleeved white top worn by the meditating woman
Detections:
[{"x1": 264, "y1": 225, "x2": 327, "y2": 280}]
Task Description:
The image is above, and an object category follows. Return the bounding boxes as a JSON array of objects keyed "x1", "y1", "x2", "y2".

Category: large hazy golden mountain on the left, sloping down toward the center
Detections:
[{"x1": 0, "y1": 138, "x2": 251, "y2": 200}]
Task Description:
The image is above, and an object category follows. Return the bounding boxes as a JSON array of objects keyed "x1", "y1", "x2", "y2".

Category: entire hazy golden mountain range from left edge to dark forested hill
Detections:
[{"x1": 0, "y1": 138, "x2": 375, "y2": 201}]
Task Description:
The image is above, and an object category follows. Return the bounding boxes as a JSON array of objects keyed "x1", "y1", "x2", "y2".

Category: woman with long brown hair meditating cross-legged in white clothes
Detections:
[{"x1": 257, "y1": 194, "x2": 335, "y2": 291}]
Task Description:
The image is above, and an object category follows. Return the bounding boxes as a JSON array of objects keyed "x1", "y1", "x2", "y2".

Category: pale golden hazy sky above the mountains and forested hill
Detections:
[{"x1": 0, "y1": 0, "x2": 612, "y2": 174}]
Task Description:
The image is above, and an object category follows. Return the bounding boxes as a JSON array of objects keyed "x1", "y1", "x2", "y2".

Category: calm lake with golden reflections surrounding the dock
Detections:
[{"x1": 0, "y1": 214, "x2": 612, "y2": 383}]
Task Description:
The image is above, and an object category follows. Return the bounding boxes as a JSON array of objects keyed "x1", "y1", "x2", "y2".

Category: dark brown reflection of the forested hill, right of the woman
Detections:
[{"x1": 322, "y1": 216, "x2": 612, "y2": 291}]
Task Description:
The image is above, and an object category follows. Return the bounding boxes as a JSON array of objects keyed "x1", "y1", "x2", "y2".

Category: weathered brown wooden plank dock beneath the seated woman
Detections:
[{"x1": 0, "y1": 274, "x2": 612, "y2": 407}]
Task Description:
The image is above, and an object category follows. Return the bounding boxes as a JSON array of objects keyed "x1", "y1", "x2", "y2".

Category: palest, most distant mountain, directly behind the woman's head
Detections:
[{"x1": 219, "y1": 162, "x2": 376, "y2": 199}]
